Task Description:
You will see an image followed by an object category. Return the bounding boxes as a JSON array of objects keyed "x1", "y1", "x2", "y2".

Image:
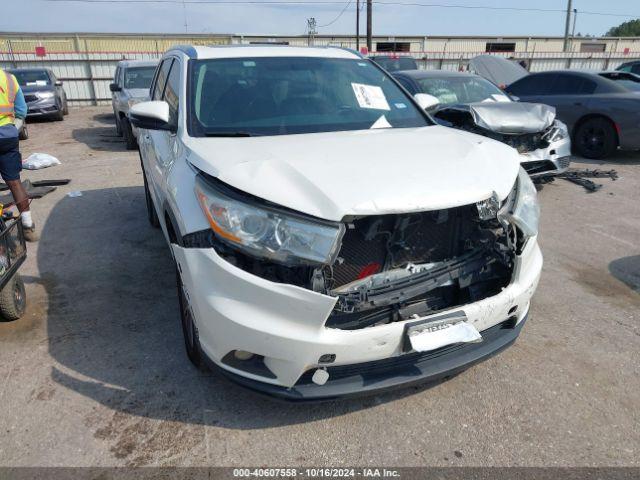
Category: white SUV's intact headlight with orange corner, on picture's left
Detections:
[{"x1": 195, "y1": 177, "x2": 344, "y2": 265}]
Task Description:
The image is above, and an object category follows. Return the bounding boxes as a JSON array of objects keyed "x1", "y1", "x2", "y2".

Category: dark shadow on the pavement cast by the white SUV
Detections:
[{"x1": 37, "y1": 187, "x2": 448, "y2": 429}]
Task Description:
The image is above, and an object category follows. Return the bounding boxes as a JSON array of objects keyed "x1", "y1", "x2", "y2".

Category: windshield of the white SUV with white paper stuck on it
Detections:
[{"x1": 189, "y1": 57, "x2": 430, "y2": 136}]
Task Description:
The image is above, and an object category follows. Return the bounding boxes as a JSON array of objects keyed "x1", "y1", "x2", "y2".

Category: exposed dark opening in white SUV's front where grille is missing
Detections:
[{"x1": 189, "y1": 199, "x2": 519, "y2": 329}]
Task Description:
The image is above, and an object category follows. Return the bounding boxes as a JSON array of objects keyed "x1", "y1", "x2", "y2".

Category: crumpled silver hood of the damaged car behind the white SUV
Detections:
[{"x1": 452, "y1": 102, "x2": 556, "y2": 135}]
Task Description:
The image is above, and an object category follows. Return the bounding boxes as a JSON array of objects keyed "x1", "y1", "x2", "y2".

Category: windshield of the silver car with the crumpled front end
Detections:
[{"x1": 417, "y1": 76, "x2": 509, "y2": 105}]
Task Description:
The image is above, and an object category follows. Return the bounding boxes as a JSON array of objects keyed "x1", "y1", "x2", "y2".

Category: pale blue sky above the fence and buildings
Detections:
[{"x1": 0, "y1": 0, "x2": 640, "y2": 36}]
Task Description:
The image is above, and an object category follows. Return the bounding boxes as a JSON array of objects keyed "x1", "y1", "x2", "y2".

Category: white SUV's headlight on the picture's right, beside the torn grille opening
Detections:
[{"x1": 499, "y1": 167, "x2": 540, "y2": 237}]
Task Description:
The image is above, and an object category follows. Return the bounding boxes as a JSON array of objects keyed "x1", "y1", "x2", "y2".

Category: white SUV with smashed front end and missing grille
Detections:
[{"x1": 129, "y1": 46, "x2": 542, "y2": 400}]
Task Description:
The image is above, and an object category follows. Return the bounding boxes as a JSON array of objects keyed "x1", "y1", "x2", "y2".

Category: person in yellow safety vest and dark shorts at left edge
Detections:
[{"x1": 0, "y1": 69, "x2": 38, "y2": 242}]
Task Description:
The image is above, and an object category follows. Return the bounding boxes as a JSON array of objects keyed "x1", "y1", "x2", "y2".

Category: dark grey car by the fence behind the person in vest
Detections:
[{"x1": 7, "y1": 68, "x2": 69, "y2": 120}]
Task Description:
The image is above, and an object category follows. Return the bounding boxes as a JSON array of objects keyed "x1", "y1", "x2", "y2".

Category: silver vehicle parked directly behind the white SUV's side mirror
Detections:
[{"x1": 109, "y1": 60, "x2": 158, "y2": 150}]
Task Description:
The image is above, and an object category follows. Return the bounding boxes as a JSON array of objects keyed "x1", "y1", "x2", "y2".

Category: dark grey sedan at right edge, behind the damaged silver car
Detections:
[{"x1": 505, "y1": 70, "x2": 640, "y2": 159}]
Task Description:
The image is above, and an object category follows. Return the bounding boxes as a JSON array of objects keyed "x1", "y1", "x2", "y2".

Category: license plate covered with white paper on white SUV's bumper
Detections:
[{"x1": 404, "y1": 312, "x2": 482, "y2": 352}]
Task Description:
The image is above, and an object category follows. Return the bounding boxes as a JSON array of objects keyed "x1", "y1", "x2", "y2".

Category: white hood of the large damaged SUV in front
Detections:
[{"x1": 185, "y1": 126, "x2": 520, "y2": 221}]
